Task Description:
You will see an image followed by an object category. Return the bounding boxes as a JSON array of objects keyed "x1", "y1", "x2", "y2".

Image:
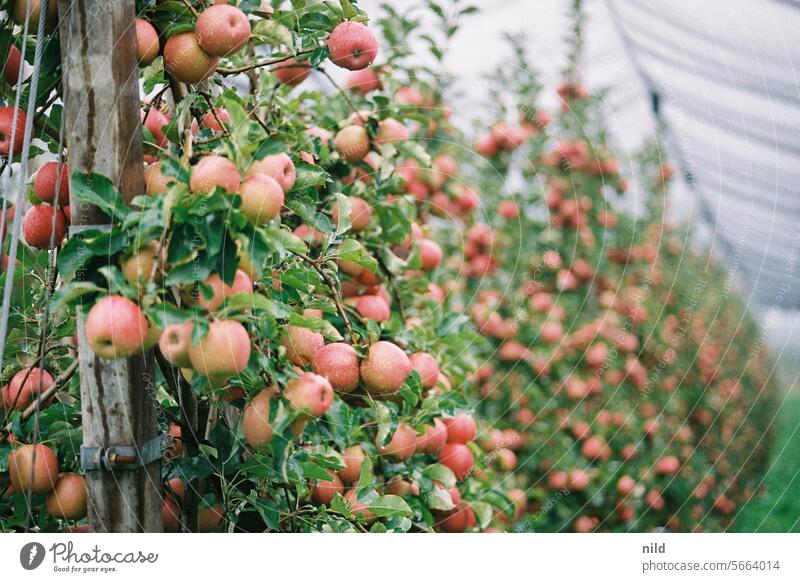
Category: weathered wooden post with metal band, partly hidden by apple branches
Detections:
[{"x1": 58, "y1": 0, "x2": 163, "y2": 532}]
